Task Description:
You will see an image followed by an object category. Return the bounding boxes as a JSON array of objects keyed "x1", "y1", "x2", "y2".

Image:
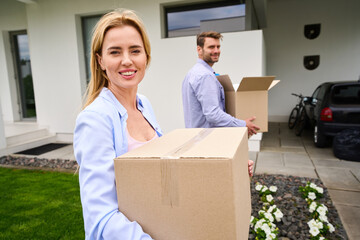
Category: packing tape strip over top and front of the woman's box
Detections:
[{"x1": 160, "y1": 128, "x2": 213, "y2": 207}]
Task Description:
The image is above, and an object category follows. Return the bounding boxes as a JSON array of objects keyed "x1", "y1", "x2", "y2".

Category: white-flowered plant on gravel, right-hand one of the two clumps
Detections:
[{"x1": 299, "y1": 182, "x2": 335, "y2": 240}]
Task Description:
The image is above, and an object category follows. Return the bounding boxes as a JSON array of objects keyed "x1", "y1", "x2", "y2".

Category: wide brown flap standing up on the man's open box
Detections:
[{"x1": 237, "y1": 76, "x2": 275, "y2": 92}]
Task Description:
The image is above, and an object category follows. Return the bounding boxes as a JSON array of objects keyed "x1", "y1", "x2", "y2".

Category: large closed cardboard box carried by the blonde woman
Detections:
[{"x1": 114, "y1": 128, "x2": 251, "y2": 240}]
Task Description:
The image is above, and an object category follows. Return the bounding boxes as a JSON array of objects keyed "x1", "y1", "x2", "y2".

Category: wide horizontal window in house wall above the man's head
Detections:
[{"x1": 163, "y1": 0, "x2": 245, "y2": 37}]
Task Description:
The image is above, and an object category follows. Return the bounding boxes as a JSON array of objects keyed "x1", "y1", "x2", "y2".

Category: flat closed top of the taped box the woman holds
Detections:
[{"x1": 118, "y1": 128, "x2": 247, "y2": 159}]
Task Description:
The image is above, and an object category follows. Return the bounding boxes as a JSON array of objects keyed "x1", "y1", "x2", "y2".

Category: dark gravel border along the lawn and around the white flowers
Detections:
[{"x1": 0, "y1": 155, "x2": 348, "y2": 240}]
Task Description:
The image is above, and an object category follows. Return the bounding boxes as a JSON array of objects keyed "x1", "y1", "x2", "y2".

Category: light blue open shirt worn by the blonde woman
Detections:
[{"x1": 74, "y1": 88, "x2": 162, "y2": 240}]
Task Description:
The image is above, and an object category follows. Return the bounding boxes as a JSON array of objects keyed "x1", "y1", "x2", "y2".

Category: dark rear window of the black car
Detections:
[{"x1": 331, "y1": 84, "x2": 360, "y2": 104}]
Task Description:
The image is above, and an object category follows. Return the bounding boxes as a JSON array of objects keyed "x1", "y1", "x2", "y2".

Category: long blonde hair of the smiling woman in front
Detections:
[{"x1": 84, "y1": 9, "x2": 151, "y2": 108}]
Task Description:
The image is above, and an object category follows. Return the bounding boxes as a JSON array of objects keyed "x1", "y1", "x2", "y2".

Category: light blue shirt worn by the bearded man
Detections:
[{"x1": 182, "y1": 59, "x2": 246, "y2": 128}]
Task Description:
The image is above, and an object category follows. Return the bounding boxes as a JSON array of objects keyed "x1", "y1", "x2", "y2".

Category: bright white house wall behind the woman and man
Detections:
[{"x1": 0, "y1": 0, "x2": 264, "y2": 139}]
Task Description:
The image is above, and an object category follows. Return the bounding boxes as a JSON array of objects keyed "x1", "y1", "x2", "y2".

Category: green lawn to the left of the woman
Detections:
[{"x1": 0, "y1": 168, "x2": 84, "y2": 240}]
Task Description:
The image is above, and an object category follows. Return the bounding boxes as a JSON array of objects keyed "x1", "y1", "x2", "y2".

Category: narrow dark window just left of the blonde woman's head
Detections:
[{"x1": 81, "y1": 15, "x2": 102, "y2": 83}]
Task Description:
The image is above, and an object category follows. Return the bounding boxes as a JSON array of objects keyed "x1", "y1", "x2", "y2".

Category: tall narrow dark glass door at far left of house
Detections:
[{"x1": 10, "y1": 30, "x2": 36, "y2": 120}]
